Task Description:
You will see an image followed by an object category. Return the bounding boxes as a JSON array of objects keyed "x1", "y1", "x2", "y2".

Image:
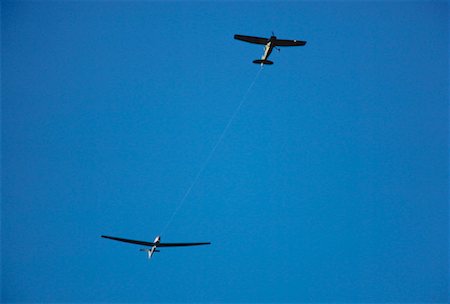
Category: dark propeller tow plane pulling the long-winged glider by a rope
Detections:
[{"x1": 234, "y1": 33, "x2": 306, "y2": 66}]
